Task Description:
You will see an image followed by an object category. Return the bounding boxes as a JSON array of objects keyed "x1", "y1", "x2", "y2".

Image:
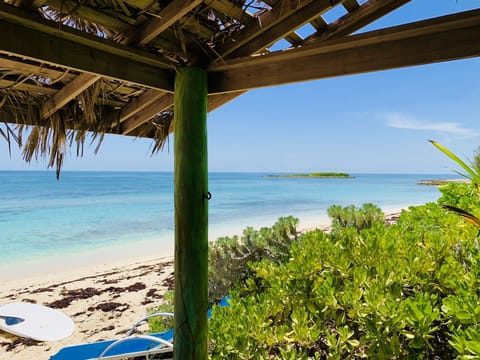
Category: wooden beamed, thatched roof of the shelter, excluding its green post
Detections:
[{"x1": 0, "y1": 0, "x2": 480, "y2": 146}]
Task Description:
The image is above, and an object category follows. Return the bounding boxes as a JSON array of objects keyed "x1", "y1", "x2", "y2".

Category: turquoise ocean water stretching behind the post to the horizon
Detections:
[{"x1": 0, "y1": 171, "x2": 453, "y2": 265}]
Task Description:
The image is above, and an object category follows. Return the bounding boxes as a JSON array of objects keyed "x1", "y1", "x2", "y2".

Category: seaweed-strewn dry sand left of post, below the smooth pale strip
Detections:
[{"x1": 0, "y1": 256, "x2": 174, "y2": 360}]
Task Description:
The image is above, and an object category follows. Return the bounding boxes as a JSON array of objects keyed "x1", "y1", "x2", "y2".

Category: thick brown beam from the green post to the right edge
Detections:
[{"x1": 209, "y1": 10, "x2": 480, "y2": 94}]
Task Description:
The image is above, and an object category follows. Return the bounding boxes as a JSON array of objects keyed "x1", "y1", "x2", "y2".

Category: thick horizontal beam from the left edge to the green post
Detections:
[{"x1": 0, "y1": 3, "x2": 173, "y2": 92}]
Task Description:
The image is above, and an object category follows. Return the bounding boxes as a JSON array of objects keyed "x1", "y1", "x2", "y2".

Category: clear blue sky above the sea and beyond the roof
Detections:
[{"x1": 0, "y1": 0, "x2": 480, "y2": 173}]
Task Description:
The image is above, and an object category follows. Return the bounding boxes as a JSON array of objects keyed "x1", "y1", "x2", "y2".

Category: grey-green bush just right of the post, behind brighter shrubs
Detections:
[{"x1": 209, "y1": 216, "x2": 298, "y2": 304}]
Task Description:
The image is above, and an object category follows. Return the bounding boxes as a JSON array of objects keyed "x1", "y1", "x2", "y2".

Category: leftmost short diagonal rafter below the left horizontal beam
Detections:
[{"x1": 40, "y1": 74, "x2": 100, "y2": 119}]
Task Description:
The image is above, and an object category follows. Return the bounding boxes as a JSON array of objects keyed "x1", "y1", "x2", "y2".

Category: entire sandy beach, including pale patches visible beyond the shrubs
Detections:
[{"x1": 0, "y1": 209, "x2": 401, "y2": 360}]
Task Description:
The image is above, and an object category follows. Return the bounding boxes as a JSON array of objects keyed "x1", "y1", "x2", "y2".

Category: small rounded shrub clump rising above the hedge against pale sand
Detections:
[{"x1": 327, "y1": 203, "x2": 385, "y2": 231}]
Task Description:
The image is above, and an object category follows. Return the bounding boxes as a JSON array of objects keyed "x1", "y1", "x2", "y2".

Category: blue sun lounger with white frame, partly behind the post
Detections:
[{"x1": 50, "y1": 297, "x2": 229, "y2": 360}]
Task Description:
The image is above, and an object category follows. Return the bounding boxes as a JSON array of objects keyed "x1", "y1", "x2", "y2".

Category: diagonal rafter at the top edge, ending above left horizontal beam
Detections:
[{"x1": 129, "y1": 0, "x2": 203, "y2": 45}]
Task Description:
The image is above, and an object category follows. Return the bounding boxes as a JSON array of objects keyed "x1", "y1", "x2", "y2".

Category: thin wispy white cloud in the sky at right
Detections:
[{"x1": 383, "y1": 113, "x2": 480, "y2": 137}]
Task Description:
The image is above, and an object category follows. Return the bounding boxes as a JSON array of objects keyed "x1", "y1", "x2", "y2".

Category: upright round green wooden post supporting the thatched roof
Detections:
[{"x1": 174, "y1": 67, "x2": 208, "y2": 360}]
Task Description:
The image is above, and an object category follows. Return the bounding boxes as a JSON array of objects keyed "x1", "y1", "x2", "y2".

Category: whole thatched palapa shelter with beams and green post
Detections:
[{"x1": 0, "y1": 0, "x2": 480, "y2": 359}]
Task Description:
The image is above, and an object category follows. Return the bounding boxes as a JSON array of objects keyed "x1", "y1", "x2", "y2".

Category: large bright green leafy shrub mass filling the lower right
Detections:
[{"x1": 209, "y1": 195, "x2": 480, "y2": 359}]
